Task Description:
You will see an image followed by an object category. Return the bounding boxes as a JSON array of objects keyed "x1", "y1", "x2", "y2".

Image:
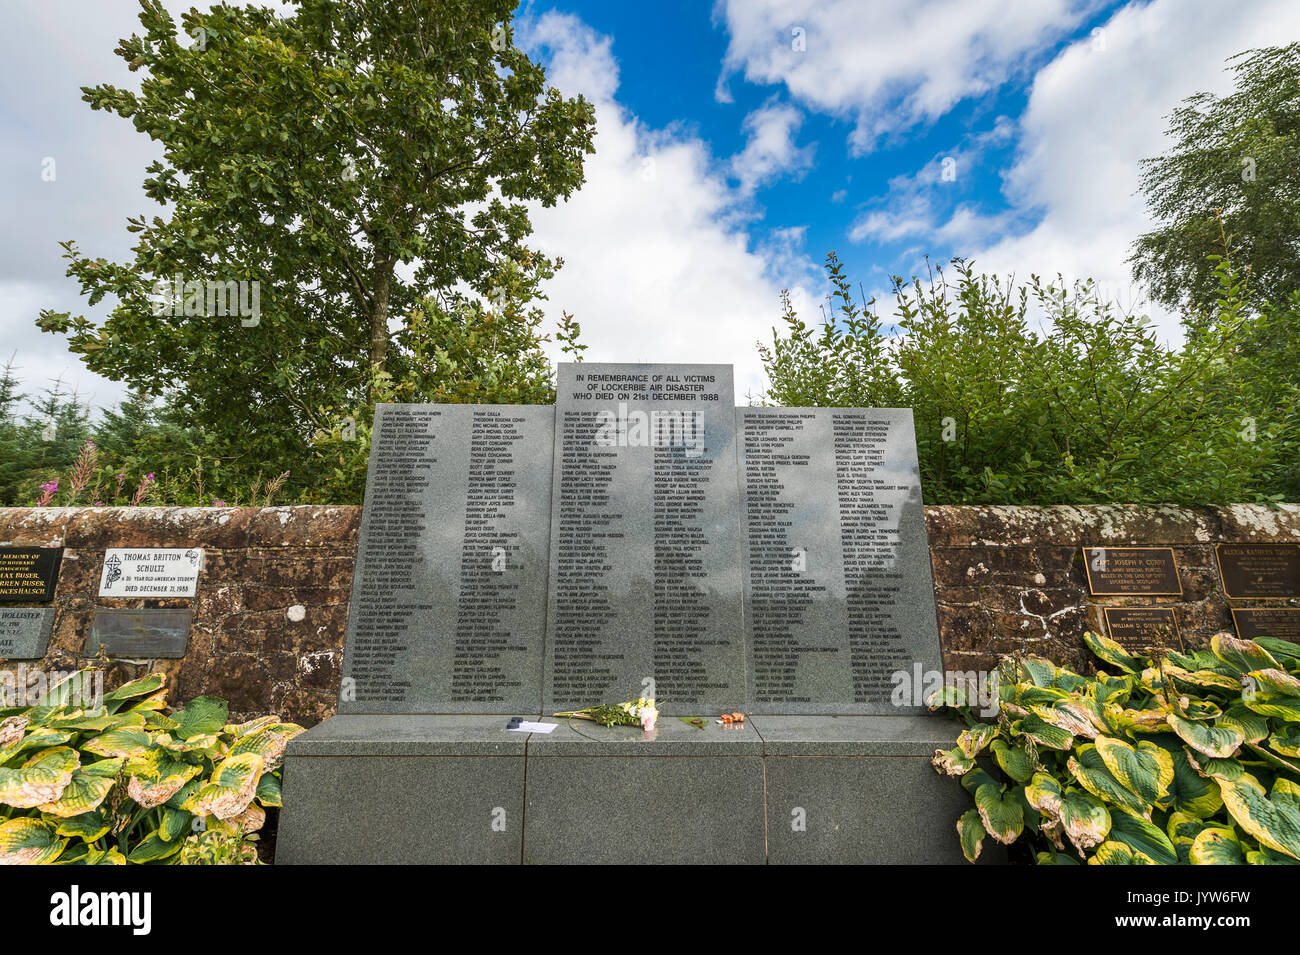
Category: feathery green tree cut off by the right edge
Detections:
[{"x1": 1130, "y1": 43, "x2": 1300, "y2": 314}]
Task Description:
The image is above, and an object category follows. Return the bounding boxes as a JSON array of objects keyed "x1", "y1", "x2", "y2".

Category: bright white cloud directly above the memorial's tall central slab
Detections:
[{"x1": 516, "y1": 13, "x2": 818, "y2": 399}]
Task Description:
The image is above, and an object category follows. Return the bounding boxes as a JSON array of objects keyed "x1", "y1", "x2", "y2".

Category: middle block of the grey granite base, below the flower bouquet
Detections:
[{"x1": 524, "y1": 748, "x2": 764, "y2": 865}]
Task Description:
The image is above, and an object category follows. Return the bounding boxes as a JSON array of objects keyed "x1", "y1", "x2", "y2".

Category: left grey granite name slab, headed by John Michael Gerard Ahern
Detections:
[{"x1": 339, "y1": 404, "x2": 554, "y2": 713}]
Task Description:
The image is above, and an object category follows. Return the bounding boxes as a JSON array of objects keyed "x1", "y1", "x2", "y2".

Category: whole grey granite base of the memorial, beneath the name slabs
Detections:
[{"x1": 276, "y1": 716, "x2": 970, "y2": 864}]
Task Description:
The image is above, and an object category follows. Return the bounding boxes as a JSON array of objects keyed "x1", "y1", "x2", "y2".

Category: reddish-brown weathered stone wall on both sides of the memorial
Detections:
[{"x1": 0, "y1": 504, "x2": 1300, "y2": 725}]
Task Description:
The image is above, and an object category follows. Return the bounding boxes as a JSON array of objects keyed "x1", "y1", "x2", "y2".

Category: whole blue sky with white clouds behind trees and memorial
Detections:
[{"x1": 0, "y1": 0, "x2": 1300, "y2": 404}]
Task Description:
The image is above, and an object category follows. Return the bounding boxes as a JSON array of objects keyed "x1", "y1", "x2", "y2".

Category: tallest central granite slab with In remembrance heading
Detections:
[{"x1": 545, "y1": 363, "x2": 746, "y2": 713}]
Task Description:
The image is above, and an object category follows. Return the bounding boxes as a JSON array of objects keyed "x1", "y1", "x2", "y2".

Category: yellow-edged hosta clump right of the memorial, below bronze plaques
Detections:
[{"x1": 933, "y1": 633, "x2": 1300, "y2": 865}]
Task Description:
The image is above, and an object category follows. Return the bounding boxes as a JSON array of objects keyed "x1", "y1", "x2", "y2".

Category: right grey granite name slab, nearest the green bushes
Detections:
[{"x1": 736, "y1": 408, "x2": 943, "y2": 715}]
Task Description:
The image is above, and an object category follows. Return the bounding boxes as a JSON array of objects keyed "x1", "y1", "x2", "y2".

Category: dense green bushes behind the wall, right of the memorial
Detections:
[{"x1": 759, "y1": 253, "x2": 1274, "y2": 504}]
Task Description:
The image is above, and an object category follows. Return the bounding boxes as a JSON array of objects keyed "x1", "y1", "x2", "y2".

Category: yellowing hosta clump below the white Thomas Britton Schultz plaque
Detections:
[{"x1": 0, "y1": 673, "x2": 303, "y2": 865}]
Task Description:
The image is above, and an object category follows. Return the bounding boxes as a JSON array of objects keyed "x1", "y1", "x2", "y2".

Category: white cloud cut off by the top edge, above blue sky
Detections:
[{"x1": 714, "y1": 0, "x2": 1101, "y2": 152}]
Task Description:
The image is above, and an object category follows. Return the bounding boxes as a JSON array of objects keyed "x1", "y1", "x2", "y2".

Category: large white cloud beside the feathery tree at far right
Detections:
[{"x1": 974, "y1": 0, "x2": 1300, "y2": 339}]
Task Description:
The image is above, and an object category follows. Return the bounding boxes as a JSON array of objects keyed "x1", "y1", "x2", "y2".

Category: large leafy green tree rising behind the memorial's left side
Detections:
[{"x1": 39, "y1": 0, "x2": 594, "y2": 501}]
